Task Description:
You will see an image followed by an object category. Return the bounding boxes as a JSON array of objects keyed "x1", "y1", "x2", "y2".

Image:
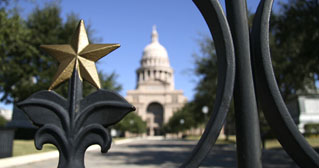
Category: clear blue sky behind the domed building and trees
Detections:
[{"x1": 0, "y1": 0, "x2": 284, "y2": 108}]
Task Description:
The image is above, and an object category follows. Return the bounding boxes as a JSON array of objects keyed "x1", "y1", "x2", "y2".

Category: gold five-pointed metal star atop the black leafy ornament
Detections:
[{"x1": 41, "y1": 20, "x2": 120, "y2": 90}]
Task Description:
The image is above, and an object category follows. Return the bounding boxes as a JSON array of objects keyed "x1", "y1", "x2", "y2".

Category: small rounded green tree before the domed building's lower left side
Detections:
[{"x1": 114, "y1": 112, "x2": 146, "y2": 134}]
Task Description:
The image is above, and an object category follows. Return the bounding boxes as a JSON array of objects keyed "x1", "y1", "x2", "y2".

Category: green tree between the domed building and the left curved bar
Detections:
[{"x1": 164, "y1": 36, "x2": 221, "y2": 133}]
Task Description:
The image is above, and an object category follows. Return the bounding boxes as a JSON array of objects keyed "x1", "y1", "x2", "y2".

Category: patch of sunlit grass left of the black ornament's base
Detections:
[{"x1": 13, "y1": 140, "x2": 56, "y2": 156}]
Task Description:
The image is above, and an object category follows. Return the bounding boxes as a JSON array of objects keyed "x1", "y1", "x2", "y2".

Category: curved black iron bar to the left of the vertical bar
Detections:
[{"x1": 181, "y1": 0, "x2": 235, "y2": 167}]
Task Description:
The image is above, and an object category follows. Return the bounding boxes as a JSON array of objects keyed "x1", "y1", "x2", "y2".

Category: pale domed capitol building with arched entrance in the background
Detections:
[{"x1": 126, "y1": 26, "x2": 187, "y2": 136}]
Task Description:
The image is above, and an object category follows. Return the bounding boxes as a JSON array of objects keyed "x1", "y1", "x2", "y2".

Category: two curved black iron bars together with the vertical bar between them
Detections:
[{"x1": 181, "y1": 0, "x2": 319, "y2": 168}]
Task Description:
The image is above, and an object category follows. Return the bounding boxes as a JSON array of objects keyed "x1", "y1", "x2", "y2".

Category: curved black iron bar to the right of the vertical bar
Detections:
[{"x1": 251, "y1": 0, "x2": 319, "y2": 168}]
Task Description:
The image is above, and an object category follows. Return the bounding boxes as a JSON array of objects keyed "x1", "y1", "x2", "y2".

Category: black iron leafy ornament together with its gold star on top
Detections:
[{"x1": 18, "y1": 20, "x2": 135, "y2": 168}]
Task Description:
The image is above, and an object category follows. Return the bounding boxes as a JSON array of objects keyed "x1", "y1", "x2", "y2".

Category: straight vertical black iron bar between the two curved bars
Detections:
[{"x1": 226, "y1": 0, "x2": 262, "y2": 168}]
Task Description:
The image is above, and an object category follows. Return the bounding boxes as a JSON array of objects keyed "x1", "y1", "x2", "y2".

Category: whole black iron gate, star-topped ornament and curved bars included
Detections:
[{"x1": 19, "y1": 0, "x2": 319, "y2": 168}]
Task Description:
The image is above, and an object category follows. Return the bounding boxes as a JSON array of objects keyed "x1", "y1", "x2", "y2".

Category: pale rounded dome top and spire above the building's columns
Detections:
[{"x1": 141, "y1": 26, "x2": 170, "y2": 67}]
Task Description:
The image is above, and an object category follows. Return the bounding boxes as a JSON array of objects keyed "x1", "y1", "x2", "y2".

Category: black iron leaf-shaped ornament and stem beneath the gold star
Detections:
[{"x1": 18, "y1": 72, "x2": 135, "y2": 168}]
